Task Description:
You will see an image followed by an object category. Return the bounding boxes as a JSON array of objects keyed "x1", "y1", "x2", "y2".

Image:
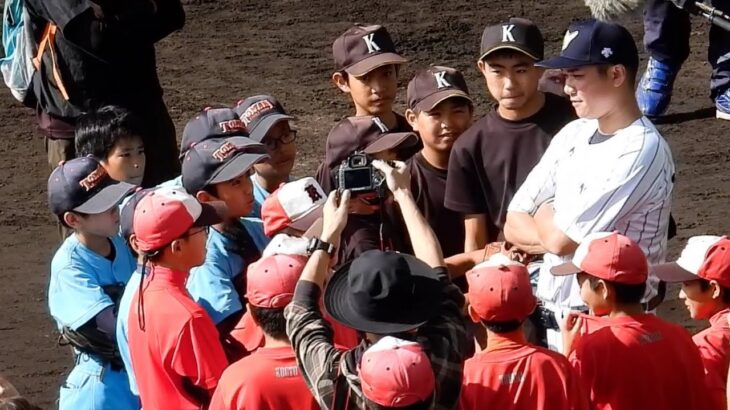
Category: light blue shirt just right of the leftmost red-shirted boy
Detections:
[{"x1": 186, "y1": 229, "x2": 245, "y2": 325}]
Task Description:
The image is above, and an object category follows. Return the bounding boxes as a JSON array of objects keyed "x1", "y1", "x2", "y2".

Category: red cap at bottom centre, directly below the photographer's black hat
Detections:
[{"x1": 358, "y1": 336, "x2": 436, "y2": 408}]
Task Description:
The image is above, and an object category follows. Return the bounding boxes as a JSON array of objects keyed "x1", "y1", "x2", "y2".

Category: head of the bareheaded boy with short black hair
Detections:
[{"x1": 75, "y1": 105, "x2": 146, "y2": 185}]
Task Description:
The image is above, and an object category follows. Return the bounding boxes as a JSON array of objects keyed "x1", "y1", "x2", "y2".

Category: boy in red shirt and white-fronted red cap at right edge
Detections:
[{"x1": 651, "y1": 235, "x2": 730, "y2": 409}]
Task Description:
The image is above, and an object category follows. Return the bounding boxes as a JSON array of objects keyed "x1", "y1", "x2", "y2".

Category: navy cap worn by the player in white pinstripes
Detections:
[{"x1": 536, "y1": 19, "x2": 639, "y2": 68}]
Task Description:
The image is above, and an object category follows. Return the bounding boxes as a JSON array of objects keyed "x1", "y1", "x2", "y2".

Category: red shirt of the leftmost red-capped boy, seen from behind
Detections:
[{"x1": 128, "y1": 266, "x2": 228, "y2": 410}]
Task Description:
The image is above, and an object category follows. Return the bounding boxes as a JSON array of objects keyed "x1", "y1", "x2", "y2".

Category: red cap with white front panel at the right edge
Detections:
[{"x1": 651, "y1": 235, "x2": 730, "y2": 288}]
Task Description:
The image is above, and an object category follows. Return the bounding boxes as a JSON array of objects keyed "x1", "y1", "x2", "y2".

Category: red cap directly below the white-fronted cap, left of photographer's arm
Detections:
[{"x1": 246, "y1": 254, "x2": 307, "y2": 309}]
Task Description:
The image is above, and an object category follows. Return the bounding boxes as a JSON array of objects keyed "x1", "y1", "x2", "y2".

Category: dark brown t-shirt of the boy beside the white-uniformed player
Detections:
[{"x1": 444, "y1": 93, "x2": 576, "y2": 241}]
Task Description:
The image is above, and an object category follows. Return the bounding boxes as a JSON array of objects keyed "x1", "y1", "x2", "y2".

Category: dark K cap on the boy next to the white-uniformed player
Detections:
[{"x1": 479, "y1": 17, "x2": 545, "y2": 61}]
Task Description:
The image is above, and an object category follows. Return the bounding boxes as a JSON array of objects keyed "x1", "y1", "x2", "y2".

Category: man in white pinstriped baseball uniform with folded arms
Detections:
[{"x1": 505, "y1": 20, "x2": 674, "y2": 351}]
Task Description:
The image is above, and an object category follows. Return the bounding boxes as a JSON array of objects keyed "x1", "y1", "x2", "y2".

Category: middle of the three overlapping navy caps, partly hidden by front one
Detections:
[{"x1": 180, "y1": 108, "x2": 248, "y2": 158}]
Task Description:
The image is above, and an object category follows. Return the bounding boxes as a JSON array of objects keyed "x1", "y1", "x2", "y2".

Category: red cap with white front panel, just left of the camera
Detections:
[{"x1": 261, "y1": 177, "x2": 327, "y2": 237}]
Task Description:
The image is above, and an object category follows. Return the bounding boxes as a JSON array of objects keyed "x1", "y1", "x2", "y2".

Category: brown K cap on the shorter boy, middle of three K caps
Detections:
[{"x1": 407, "y1": 66, "x2": 471, "y2": 111}]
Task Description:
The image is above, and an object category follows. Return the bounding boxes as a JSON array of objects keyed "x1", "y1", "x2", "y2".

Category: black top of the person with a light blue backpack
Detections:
[{"x1": 26, "y1": 0, "x2": 185, "y2": 118}]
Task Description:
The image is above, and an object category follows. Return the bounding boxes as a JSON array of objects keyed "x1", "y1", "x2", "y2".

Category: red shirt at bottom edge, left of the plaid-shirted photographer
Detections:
[{"x1": 209, "y1": 346, "x2": 319, "y2": 410}]
